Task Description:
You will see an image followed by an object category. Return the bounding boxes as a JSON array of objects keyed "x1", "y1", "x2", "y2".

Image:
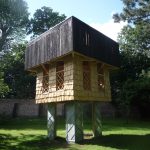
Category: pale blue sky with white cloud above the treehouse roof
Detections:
[{"x1": 26, "y1": 0, "x2": 126, "y2": 41}]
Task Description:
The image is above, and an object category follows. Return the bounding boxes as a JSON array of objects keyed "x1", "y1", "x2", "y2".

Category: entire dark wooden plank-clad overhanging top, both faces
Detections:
[{"x1": 25, "y1": 17, "x2": 119, "y2": 70}]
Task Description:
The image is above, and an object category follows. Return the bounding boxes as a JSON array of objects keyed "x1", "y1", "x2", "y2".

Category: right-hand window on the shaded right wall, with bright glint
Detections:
[{"x1": 97, "y1": 63, "x2": 105, "y2": 92}]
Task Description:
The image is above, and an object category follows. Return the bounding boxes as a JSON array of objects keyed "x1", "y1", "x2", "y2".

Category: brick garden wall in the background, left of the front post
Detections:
[{"x1": 0, "y1": 99, "x2": 64, "y2": 117}]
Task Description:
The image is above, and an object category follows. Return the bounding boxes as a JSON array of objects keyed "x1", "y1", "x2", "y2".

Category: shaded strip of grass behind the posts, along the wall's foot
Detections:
[{"x1": 0, "y1": 118, "x2": 150, "y2": 131}]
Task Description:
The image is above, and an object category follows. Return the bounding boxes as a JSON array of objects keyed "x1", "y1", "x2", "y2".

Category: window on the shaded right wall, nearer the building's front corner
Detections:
[{"x1": 82, "y1": 61, "x2": 91, "y2": 90}]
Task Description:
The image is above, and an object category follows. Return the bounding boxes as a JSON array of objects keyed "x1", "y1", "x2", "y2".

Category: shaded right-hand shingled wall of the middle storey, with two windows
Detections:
[{"x1": 73, "y1": 55, "x2": 111, "y2": 101}]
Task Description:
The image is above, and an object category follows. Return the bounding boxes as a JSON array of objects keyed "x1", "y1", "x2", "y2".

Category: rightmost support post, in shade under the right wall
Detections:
[{"x1": 92, "y1": 102, "x2": 102, "y2": 137}]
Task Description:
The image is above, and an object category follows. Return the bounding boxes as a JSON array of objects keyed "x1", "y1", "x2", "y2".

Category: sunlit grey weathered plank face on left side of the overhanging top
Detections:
[{"x1": 25, "y1": 18, "x2": 73, "y2": 70}]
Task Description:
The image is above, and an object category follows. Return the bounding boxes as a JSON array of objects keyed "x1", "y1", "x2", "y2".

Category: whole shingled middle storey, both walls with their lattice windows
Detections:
[{"x1": 36, "y1": 55, "x2": 111, "y2": 103}]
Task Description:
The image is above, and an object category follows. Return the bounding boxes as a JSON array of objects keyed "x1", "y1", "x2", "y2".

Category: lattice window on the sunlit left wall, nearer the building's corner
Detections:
[{"x1": 56, "y1": 61, "x2": 64, "y2": 90}]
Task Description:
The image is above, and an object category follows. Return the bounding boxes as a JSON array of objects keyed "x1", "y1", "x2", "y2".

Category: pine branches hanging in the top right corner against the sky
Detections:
[{"x1": 113, "y1": 0, "x2": 150, "y2": 24}]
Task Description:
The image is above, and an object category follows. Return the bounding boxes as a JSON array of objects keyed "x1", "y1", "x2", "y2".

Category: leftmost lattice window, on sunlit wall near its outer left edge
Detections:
[{"x1": 42, "y1": 65, "x2": 49, "y2": 93}]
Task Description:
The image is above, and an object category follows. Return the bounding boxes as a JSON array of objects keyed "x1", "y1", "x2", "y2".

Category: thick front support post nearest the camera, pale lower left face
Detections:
[{"x1": 66, "y1": 102, "x2": 83, "y2": 143}]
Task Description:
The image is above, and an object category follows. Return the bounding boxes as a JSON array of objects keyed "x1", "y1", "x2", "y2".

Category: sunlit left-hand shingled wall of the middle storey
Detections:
[{"x1": 36, "y1": 56, "x2": 74, "y2": 103}]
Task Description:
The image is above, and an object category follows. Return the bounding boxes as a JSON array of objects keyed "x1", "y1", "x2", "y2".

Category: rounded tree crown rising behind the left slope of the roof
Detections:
[{"x1": 27, "y1": 6, "x2": 66, "y2": 36}]
